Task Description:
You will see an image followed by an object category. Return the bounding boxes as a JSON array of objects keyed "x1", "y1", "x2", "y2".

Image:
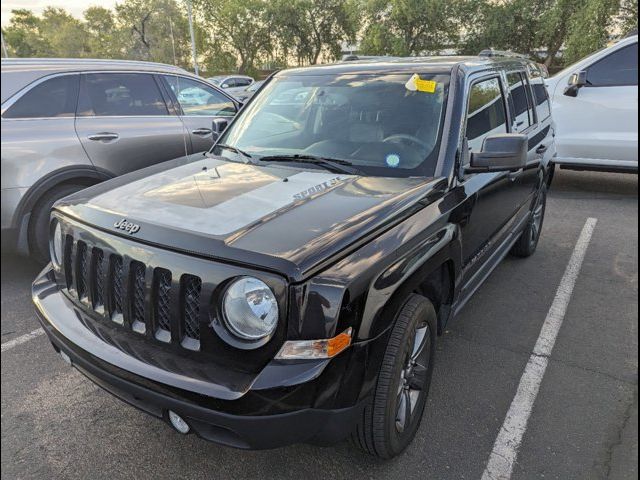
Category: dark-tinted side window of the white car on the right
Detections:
[{"x1": 587, "y1": 43, "x2": 638, "y2": 87}]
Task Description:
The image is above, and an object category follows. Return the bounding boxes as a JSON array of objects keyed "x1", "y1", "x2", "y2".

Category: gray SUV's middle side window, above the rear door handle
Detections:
[{"x1": 78, "y1": 73, "x2": 169, "y2": 117}]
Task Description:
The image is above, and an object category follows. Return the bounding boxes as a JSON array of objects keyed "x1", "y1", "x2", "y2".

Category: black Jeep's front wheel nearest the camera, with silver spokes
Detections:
[{"x1": 352, "y1": 294, "x2": 437, "y2": 459}]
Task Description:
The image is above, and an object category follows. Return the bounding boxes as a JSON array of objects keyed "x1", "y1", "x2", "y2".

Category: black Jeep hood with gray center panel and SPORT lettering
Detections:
[{"x1": 56, "y1": 154, "x2": 442, "y2": 280}]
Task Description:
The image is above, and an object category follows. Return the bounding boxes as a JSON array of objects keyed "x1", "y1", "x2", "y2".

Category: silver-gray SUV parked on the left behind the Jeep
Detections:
[{"x1": 2, "y1": 59, "x2": 239, "y2": 260}]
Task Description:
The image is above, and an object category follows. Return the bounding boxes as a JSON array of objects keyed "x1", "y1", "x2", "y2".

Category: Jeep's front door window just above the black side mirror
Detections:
[{"x1": 466, "y1": 78, "x2": 507, "y2": 151}]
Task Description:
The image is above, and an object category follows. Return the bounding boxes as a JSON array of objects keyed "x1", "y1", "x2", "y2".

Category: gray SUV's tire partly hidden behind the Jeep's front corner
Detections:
[{"x1": 28, "y1": 184, "x2": 86, "y2": 264}]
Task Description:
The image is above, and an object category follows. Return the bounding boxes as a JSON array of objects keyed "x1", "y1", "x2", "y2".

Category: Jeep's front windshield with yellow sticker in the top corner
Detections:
[{"x1": 213, "y1": 73, "x2": 449, "y2": 177}]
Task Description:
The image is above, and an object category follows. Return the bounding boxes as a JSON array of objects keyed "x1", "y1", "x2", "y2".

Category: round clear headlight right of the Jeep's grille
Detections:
[{"x1": 222, "y1": 277, "x2": 278, "y2": 341}]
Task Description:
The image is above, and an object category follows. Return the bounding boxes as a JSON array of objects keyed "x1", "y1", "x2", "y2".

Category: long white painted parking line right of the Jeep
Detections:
[{"x1": 482, "y1": 218, "x2": 598, "y2": 480}]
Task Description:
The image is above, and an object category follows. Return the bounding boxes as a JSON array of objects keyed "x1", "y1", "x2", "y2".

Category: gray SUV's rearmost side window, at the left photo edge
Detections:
[{"x1": 3, "y1": 75, "x2": 80, "y2": 118}]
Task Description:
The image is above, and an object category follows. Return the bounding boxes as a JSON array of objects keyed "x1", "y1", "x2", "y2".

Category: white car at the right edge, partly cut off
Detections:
[{"x1": 547, "y1": 33, "x2": 638, "y2": 173}]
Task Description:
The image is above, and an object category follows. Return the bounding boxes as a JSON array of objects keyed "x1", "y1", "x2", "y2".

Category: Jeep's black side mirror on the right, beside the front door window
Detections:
[{"x1": 465, "y1": 133, "x2": 529, "y2": 173}]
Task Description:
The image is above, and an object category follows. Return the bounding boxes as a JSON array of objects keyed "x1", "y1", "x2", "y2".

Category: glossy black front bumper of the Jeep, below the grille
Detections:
[{"x1": 32, "y1": 269, "x2": 365, "y2": 449}]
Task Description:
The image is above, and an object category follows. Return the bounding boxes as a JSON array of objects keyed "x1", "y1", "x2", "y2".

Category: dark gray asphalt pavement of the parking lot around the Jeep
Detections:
[{"x1": 1, "y1": 171, "x2": 638, "y2": 480}]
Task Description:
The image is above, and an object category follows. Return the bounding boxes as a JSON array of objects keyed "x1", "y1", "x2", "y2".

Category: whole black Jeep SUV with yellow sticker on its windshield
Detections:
[{"x1": 33, "y1": 57, "x2": 554, "y2": 458}]
